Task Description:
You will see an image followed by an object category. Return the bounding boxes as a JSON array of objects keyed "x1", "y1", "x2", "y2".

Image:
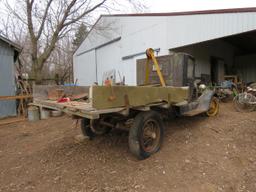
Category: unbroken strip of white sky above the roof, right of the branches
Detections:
[{"x1": 144, "y1": 0, "x2": 256, "y2": 12}]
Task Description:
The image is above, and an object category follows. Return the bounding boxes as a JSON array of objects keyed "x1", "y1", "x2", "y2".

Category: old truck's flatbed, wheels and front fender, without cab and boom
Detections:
[{"x1": 32, "y1": 86, "x2": 218, "y2": 159}]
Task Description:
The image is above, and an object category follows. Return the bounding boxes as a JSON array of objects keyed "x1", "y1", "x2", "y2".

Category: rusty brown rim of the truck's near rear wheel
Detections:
[{"x1": 141, "y1": 119, "x2": 161, "y2": 153}]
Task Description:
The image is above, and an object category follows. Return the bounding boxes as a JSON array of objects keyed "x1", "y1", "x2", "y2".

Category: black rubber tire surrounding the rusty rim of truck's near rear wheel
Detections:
[{"x1": 129, "y1": 111, "x2": 164, "y2": 160}]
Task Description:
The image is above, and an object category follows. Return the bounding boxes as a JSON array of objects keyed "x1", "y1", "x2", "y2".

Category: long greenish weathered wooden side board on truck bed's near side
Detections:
[{"x1": 92, "y1": 86, "x2": 189, "y2": 110}]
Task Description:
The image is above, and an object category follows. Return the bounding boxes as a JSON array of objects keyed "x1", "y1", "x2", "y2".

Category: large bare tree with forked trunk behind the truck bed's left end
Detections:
[{"x1": 3, "y1": 0, "x2": 145, "y2": 84}]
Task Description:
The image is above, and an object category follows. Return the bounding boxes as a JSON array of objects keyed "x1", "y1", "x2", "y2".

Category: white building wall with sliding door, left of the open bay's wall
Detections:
[{"x1": 74, "y1": 17, "x2": 169, "y2": 86}]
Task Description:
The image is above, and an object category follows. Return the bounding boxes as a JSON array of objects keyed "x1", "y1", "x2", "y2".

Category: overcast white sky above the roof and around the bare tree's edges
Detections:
[{"x1": 0, "y1": 0, "x2": 256, "y2": 37}]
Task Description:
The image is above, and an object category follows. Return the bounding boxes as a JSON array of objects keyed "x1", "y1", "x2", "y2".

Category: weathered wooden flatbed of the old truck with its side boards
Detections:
[{"x1": 32, "y1": 86, "x2": 188, "y2": 119}]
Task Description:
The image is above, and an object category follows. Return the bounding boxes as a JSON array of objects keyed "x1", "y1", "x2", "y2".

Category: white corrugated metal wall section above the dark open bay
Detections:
[{"x1": 167, "y1": 12, "x2": 256, "y2": 48}]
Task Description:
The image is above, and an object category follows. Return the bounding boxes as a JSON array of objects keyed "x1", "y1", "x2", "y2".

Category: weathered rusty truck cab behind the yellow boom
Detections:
[{"x1": 137, "y1": 53, "x2": 195, "y2": 87}]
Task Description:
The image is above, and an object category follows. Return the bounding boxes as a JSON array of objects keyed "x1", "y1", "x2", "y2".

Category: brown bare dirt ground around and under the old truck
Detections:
[{"x1": 0, "y1": 104, "x2": 256, "y2": 192}]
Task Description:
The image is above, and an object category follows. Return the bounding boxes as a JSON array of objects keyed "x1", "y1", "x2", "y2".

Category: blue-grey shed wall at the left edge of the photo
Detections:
[{"x1": 0, "y1": 41, "x2": 16, "y2": 118}]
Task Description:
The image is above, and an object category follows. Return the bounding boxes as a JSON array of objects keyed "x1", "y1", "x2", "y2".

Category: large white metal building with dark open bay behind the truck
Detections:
[{"x1": 74, "y1": 8, "x2": 256, "y2": 85}]
